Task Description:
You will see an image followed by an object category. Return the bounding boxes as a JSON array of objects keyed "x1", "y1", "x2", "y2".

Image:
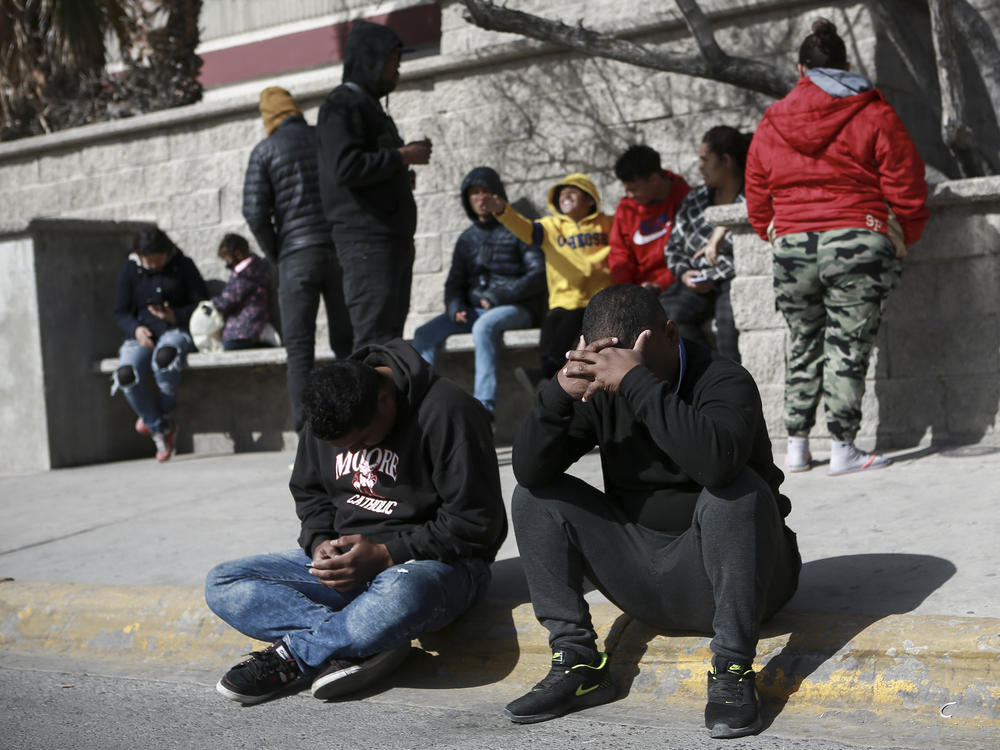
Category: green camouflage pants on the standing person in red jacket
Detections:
[{"x1": 774, "y1": 229, "x2": 900, "y2": 440}]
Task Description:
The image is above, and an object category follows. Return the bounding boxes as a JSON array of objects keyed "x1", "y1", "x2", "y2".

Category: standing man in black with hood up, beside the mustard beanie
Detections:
[{"x1": 317, "y1": 21, "x2": 431, "y2": 348}]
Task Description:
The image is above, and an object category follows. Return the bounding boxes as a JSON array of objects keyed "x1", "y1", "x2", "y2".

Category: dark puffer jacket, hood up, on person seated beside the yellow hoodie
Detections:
[{"x1": 444, "y1": 167, "x2": 546, "y2": 323}]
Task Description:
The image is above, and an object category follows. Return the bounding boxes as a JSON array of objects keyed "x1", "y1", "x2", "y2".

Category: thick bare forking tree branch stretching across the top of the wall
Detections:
[{"x1": 462, "y1": 0, "x2": 795, "y2": 98}]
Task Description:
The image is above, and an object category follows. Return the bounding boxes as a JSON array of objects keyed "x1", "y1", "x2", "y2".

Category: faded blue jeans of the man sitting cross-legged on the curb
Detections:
[{"x1": 205, "y1": 549, "x2": 490, "y2": 676}]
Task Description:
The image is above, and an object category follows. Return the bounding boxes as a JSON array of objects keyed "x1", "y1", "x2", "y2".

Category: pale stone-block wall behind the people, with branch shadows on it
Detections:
[{"x1": 0, "y1": 0, "x2": 875, "y2": 346}]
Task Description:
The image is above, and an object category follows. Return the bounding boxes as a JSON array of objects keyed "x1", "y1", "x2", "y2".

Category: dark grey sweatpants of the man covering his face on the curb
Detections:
[{"x1": 512, "y1": 469, "x2": 802, "y2": 664}]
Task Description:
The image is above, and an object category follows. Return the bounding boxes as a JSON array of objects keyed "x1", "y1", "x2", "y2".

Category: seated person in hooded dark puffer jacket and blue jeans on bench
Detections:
[{"x1": 413, "y1": 167, "x2": 546, "y2": 414}]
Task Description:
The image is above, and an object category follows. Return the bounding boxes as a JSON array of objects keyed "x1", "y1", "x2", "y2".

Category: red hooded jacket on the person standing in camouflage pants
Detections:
[{"x1": 745, "y1": 77, "x2": 927, "y2": 245}]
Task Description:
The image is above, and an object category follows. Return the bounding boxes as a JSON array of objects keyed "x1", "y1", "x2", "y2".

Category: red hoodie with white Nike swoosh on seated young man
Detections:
[{"x1": 608, "y1": 169, "x2": 691, "y2": 291}]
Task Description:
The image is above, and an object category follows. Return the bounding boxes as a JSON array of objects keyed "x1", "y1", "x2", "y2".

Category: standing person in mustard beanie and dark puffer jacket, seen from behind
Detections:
[{"x1": 243, "y1": 86, "x2": 354, "y2": 432}]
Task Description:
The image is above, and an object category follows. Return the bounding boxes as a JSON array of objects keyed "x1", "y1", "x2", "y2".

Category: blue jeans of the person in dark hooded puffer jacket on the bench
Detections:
[{"x1": 413, "y1": 305, "x2": 531, "y2": 412}]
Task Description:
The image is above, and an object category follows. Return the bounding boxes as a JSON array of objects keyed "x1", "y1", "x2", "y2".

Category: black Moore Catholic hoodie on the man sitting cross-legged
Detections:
[{"x1": 289, "y1": 339, "x2": 507, "y2": 563}]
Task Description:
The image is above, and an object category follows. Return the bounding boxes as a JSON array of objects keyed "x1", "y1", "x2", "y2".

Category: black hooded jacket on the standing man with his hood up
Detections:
[{"x1": 316, "y1": 21, "x2": 417, "y2": 242}]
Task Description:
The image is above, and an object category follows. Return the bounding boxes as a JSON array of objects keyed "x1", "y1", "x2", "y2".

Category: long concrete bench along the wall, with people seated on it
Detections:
[{"x1": 93, "y1": 329, "x2": 539, "y2": 458}]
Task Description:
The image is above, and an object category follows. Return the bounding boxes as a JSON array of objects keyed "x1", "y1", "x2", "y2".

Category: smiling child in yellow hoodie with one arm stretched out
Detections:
[{"x1": 486, "y1": 172, "x2": 614, "y2": 393}]
